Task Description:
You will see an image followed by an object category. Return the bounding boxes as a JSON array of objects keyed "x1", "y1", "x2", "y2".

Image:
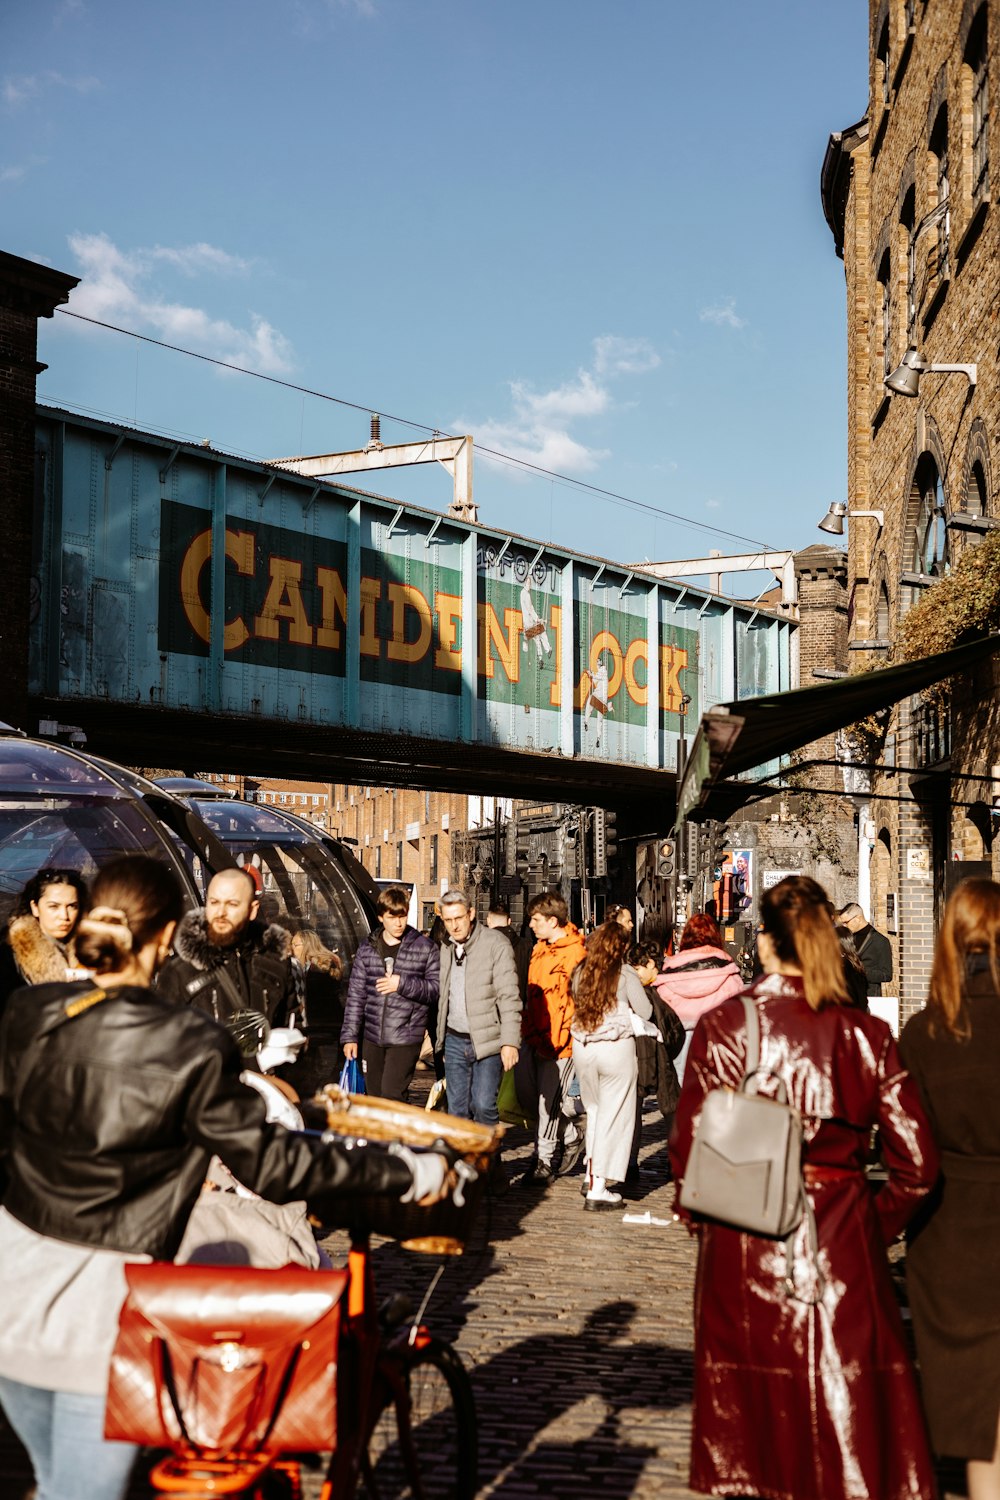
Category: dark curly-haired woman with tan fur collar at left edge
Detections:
[{"x1": 0, "y1": 869, "x2": 87, "y2": 1011}]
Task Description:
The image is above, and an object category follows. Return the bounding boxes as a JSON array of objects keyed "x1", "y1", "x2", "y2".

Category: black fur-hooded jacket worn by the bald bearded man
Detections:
[{"x1": 156, "y1": 911, "x2": 295, "y2": 1044}]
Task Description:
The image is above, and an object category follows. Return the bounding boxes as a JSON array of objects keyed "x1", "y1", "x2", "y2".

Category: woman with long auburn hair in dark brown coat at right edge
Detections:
[{"x1": 901, "y1": 881, "x2": 1000, "y2": 1500}]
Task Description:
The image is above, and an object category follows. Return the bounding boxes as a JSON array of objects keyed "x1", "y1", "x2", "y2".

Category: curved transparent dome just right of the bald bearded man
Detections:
[{"x1": 192, "y1": 797, "x2": 369, "y2": 975}]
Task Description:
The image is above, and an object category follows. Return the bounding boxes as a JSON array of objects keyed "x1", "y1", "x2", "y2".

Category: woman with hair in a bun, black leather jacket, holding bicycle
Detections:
[{"x1": 0, "y1": 857, "x2": 448, "y2": 1500}]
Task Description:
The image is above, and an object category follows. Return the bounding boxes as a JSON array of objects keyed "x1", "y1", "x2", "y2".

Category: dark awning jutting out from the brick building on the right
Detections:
[{"x1": 678, "y1": 635, "x2": 1000, "y2": 824}]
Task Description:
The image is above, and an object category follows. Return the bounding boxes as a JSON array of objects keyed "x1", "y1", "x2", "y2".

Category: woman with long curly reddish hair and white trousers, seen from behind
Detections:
[{"x1": 573, "y1": 921, "x2": 652, "y2": 1212}]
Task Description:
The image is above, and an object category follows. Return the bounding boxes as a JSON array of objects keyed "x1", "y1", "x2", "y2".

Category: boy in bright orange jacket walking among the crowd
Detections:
[{"x1": 517, "y1": 891, "x2": 586, "y2": 1188}]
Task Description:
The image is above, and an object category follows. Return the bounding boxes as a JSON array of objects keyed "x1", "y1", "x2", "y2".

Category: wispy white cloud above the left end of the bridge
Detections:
[{"x1": 69, "y1": 234, "x2": 292, "y2": 375}]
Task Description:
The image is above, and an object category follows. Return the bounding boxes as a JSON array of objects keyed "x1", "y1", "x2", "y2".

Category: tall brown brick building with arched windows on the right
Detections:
[{"x1": 822, "y1": 0, "x2": 1000, "y2": 1017}]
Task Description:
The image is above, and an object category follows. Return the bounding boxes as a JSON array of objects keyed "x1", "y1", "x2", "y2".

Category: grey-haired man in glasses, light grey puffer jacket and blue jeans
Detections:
[{"x1": 436, "y1": 891, "x2": 520, "y2": 1125}]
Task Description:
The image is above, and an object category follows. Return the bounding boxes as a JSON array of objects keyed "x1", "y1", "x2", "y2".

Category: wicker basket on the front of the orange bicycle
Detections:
[{"x1": 321, "y1": 1086, "x2": 505, "y2": 1256}]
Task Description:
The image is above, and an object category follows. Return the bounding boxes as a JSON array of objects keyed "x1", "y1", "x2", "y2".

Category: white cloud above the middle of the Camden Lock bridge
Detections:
[{"x1": 456, "y1": 335, "x2": 660, "y2": 474}]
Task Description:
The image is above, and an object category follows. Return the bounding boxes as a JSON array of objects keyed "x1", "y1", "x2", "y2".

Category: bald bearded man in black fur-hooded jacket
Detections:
[{"x1": 156, "y1": 870, "x2": 295, "y2": 1067}]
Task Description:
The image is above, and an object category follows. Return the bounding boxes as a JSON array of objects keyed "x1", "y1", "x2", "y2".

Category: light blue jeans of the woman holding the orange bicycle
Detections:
[{"x1": 0, "y1": 1376, "x2": 138, "y2": 1500}]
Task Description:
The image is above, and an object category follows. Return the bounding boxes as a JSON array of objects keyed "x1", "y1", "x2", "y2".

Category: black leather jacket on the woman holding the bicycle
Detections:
[{"x1": 0, "y1": 983, "x2": 412, "y2": 1260}]
